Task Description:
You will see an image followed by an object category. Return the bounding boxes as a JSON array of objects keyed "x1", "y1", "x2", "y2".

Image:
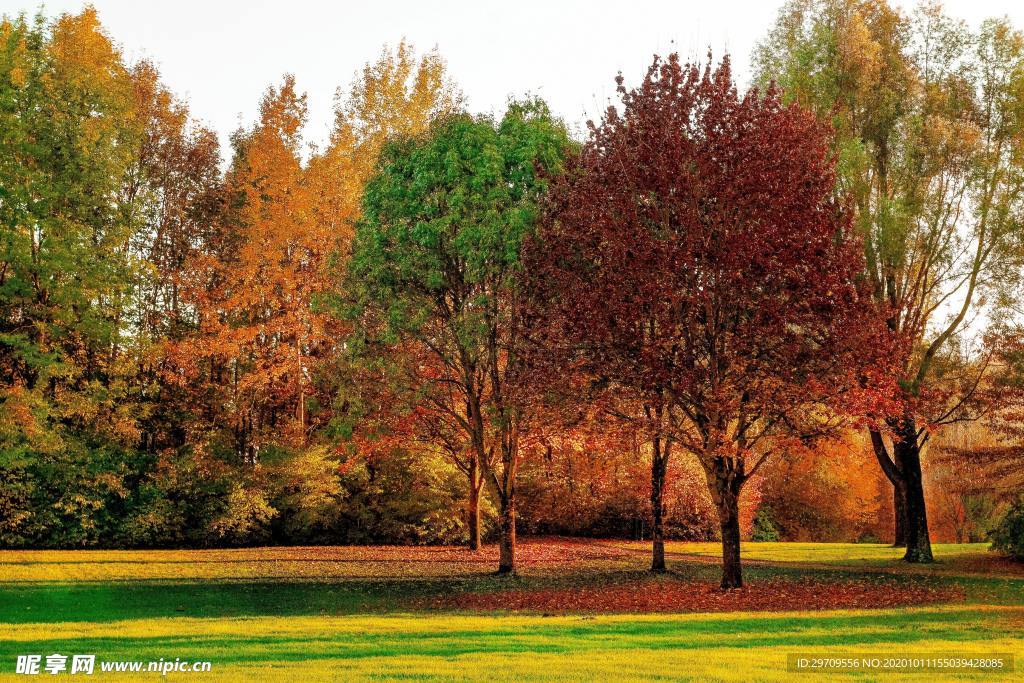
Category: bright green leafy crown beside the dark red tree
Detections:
[{"x1": 350, "y1": 99, "x2": 570, "y2": 333}]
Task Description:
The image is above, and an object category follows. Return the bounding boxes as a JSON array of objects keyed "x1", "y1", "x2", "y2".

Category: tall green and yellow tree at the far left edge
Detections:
[{"x1": 0, "y1": 9, "x2": 139, "y2": 431}]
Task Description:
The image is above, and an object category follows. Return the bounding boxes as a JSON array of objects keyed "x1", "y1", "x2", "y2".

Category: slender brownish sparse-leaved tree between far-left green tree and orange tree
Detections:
[{"x1": 118, "y1": 61, "x2": 223, "y2": 453}]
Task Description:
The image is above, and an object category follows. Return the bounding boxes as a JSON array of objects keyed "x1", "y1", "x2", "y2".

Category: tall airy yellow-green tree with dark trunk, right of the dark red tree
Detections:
[{"x1": 755, "y1": 0, "x2": 1024, "y2": 562}]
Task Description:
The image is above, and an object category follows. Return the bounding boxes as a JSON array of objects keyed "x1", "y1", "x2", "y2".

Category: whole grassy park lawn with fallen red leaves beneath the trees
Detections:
[{"x1": 0, "y1": 539, "x2": 1024, "y2": 681}]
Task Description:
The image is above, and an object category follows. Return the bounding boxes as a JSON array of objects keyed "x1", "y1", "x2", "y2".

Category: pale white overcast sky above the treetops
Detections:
[{"x1": 0, "y1": 0, "x2": 1024, "y2": 153}]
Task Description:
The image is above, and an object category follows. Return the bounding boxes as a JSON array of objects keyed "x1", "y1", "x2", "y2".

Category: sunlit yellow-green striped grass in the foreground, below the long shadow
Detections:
[{"x1": 0, "y1": 607, "x2": 1024, "y2": 680}]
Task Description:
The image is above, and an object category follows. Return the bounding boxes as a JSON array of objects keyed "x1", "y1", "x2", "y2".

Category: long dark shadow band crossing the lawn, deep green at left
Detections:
[{"x1": 0, "y1": 563, "x2": 1024, "y2": 624}]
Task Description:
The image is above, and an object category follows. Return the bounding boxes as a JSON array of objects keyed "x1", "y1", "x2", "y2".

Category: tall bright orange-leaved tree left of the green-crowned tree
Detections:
[{"x1": 173, "y1": 42, "x2": 460, "y2": 471}]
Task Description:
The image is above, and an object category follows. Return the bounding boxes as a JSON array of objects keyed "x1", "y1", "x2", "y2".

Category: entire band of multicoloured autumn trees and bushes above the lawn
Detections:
[{"x1": 0, "y1": 0, "x2": 1024, "y2": 587}]
